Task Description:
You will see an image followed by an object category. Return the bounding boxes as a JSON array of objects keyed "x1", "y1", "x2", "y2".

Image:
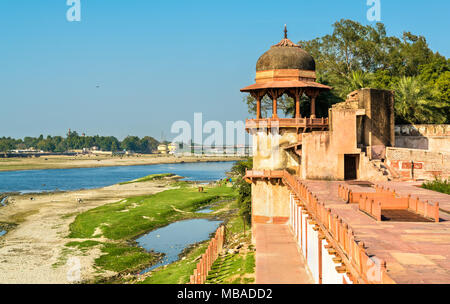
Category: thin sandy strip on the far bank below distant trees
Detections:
[{"x1": 0, "y1": 155, "x2": 242, "y2": 171}]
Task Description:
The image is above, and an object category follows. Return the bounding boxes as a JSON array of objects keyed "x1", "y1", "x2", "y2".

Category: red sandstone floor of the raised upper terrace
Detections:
[{"x1": 305, "y1": 181, "x2": 450, "y2": 284}]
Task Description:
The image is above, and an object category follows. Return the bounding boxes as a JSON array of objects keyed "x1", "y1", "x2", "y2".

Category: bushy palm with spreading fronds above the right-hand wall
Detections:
[{"x1": 395, "y1": 77, "x2": 446, "y2": 124}]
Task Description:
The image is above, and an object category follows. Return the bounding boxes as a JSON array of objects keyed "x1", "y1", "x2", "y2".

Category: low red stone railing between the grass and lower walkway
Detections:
[{"x1": 189, "y1": 226, "x2": 225, "y2": 284}]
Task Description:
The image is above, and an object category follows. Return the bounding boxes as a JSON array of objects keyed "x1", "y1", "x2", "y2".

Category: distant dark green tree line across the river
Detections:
[{"x1": 0, "y1": 132, "x2": 160, "y2": 154}]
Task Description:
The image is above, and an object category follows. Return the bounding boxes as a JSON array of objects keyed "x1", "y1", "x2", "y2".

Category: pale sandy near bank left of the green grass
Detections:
[{"x1": 0, "y1": 180, "x2": 176, "y2": 284}]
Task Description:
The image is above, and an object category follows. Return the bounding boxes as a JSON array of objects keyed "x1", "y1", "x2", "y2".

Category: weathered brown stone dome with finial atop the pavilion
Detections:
[{"x1": 256, "y1": 31, "x2": 316, "y2": 72}]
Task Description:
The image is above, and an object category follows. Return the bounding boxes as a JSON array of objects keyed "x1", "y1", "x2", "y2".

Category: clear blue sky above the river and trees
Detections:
[{"x1": 0, "y1": 0, "x2": 450, "y2": 139}]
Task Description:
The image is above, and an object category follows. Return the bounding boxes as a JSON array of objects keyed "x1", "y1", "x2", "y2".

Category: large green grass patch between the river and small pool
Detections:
[{"x1": 69, "y1": 186, "x2": 235, "y2": 240}]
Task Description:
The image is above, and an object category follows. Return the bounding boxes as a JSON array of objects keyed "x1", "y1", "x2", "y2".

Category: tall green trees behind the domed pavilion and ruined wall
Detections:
[{"x1": 244, "y1": 19, "x2": 450, "y2": 124}]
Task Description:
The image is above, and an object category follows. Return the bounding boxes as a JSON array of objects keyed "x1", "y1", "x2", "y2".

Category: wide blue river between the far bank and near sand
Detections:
[{"x1": 0, "y1": 162, "x2": 234, "y2": 193}]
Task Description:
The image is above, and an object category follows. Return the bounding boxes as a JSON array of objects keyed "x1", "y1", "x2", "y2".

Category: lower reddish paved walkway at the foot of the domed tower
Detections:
[{"x1": 255, "y1": 224, "x2": 313, "y2": 284}]
